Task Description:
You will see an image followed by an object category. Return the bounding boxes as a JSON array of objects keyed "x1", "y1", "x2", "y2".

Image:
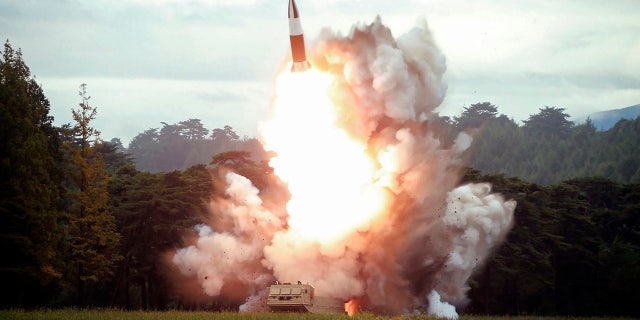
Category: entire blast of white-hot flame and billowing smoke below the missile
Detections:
[{"x1": 172, "y1": 14, "x2": 515, "y2": 318}]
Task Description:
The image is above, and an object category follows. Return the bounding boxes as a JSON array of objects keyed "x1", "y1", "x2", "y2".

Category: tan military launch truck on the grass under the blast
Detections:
[{"x1": 267, "y1": 281, "x2": 345, "y2": 313}]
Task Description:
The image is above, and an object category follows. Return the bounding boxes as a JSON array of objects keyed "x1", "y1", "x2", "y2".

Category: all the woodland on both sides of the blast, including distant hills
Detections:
[{"x1": 0, "y1": 42, "x2": 640, "y2": 317}]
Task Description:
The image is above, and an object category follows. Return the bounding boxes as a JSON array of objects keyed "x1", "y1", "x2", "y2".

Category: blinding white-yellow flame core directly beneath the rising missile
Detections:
[{"x1": 260, "y1": 69, "x2": 390, "y2": 244}]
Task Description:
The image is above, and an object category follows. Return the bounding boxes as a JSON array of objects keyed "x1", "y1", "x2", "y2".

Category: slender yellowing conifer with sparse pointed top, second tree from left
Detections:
[{"x1": 65, "y1": 84, "x2": 121, "y2": 306}]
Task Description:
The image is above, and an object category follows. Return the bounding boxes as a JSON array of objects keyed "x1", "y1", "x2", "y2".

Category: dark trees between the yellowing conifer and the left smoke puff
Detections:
[{"x1": 109, "y1": 164, "x2": 213, "y2": 309}]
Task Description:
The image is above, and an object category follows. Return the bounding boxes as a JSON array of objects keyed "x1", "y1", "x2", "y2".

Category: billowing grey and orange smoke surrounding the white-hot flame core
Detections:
[{"x1": 173, "y1": 18, "x2": 515, "y2": 318}]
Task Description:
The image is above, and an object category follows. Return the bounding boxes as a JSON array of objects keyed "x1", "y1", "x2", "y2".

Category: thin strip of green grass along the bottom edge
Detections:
[{"x1": 0, "y1": 309, "x2": 620, "y2": 320}]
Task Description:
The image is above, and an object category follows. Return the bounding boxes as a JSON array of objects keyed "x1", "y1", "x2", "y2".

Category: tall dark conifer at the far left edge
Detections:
[{"x1": 0, "y1": 41, "x2": 62, "y2": 306}]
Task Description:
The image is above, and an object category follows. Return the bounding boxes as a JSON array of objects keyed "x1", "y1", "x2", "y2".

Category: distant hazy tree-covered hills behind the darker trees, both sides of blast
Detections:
[{"x1": 127, "y1": 102, "x2": 640, "y2": 185}]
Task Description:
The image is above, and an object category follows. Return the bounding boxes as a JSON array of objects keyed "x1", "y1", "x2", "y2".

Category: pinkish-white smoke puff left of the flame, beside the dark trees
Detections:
[{"x1": 173, "y1": 172, "x2": 285, "y2": 296}]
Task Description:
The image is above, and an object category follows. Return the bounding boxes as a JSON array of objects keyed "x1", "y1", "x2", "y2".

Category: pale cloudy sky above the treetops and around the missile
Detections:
[{"x1": 0, "y1": 0, "x2": 640, "y2": 145}]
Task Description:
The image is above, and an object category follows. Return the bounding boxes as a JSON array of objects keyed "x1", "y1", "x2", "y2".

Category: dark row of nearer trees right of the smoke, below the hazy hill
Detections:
[{"x1": 465, "y1": 170, "x2": 640, "y2": 316}]
